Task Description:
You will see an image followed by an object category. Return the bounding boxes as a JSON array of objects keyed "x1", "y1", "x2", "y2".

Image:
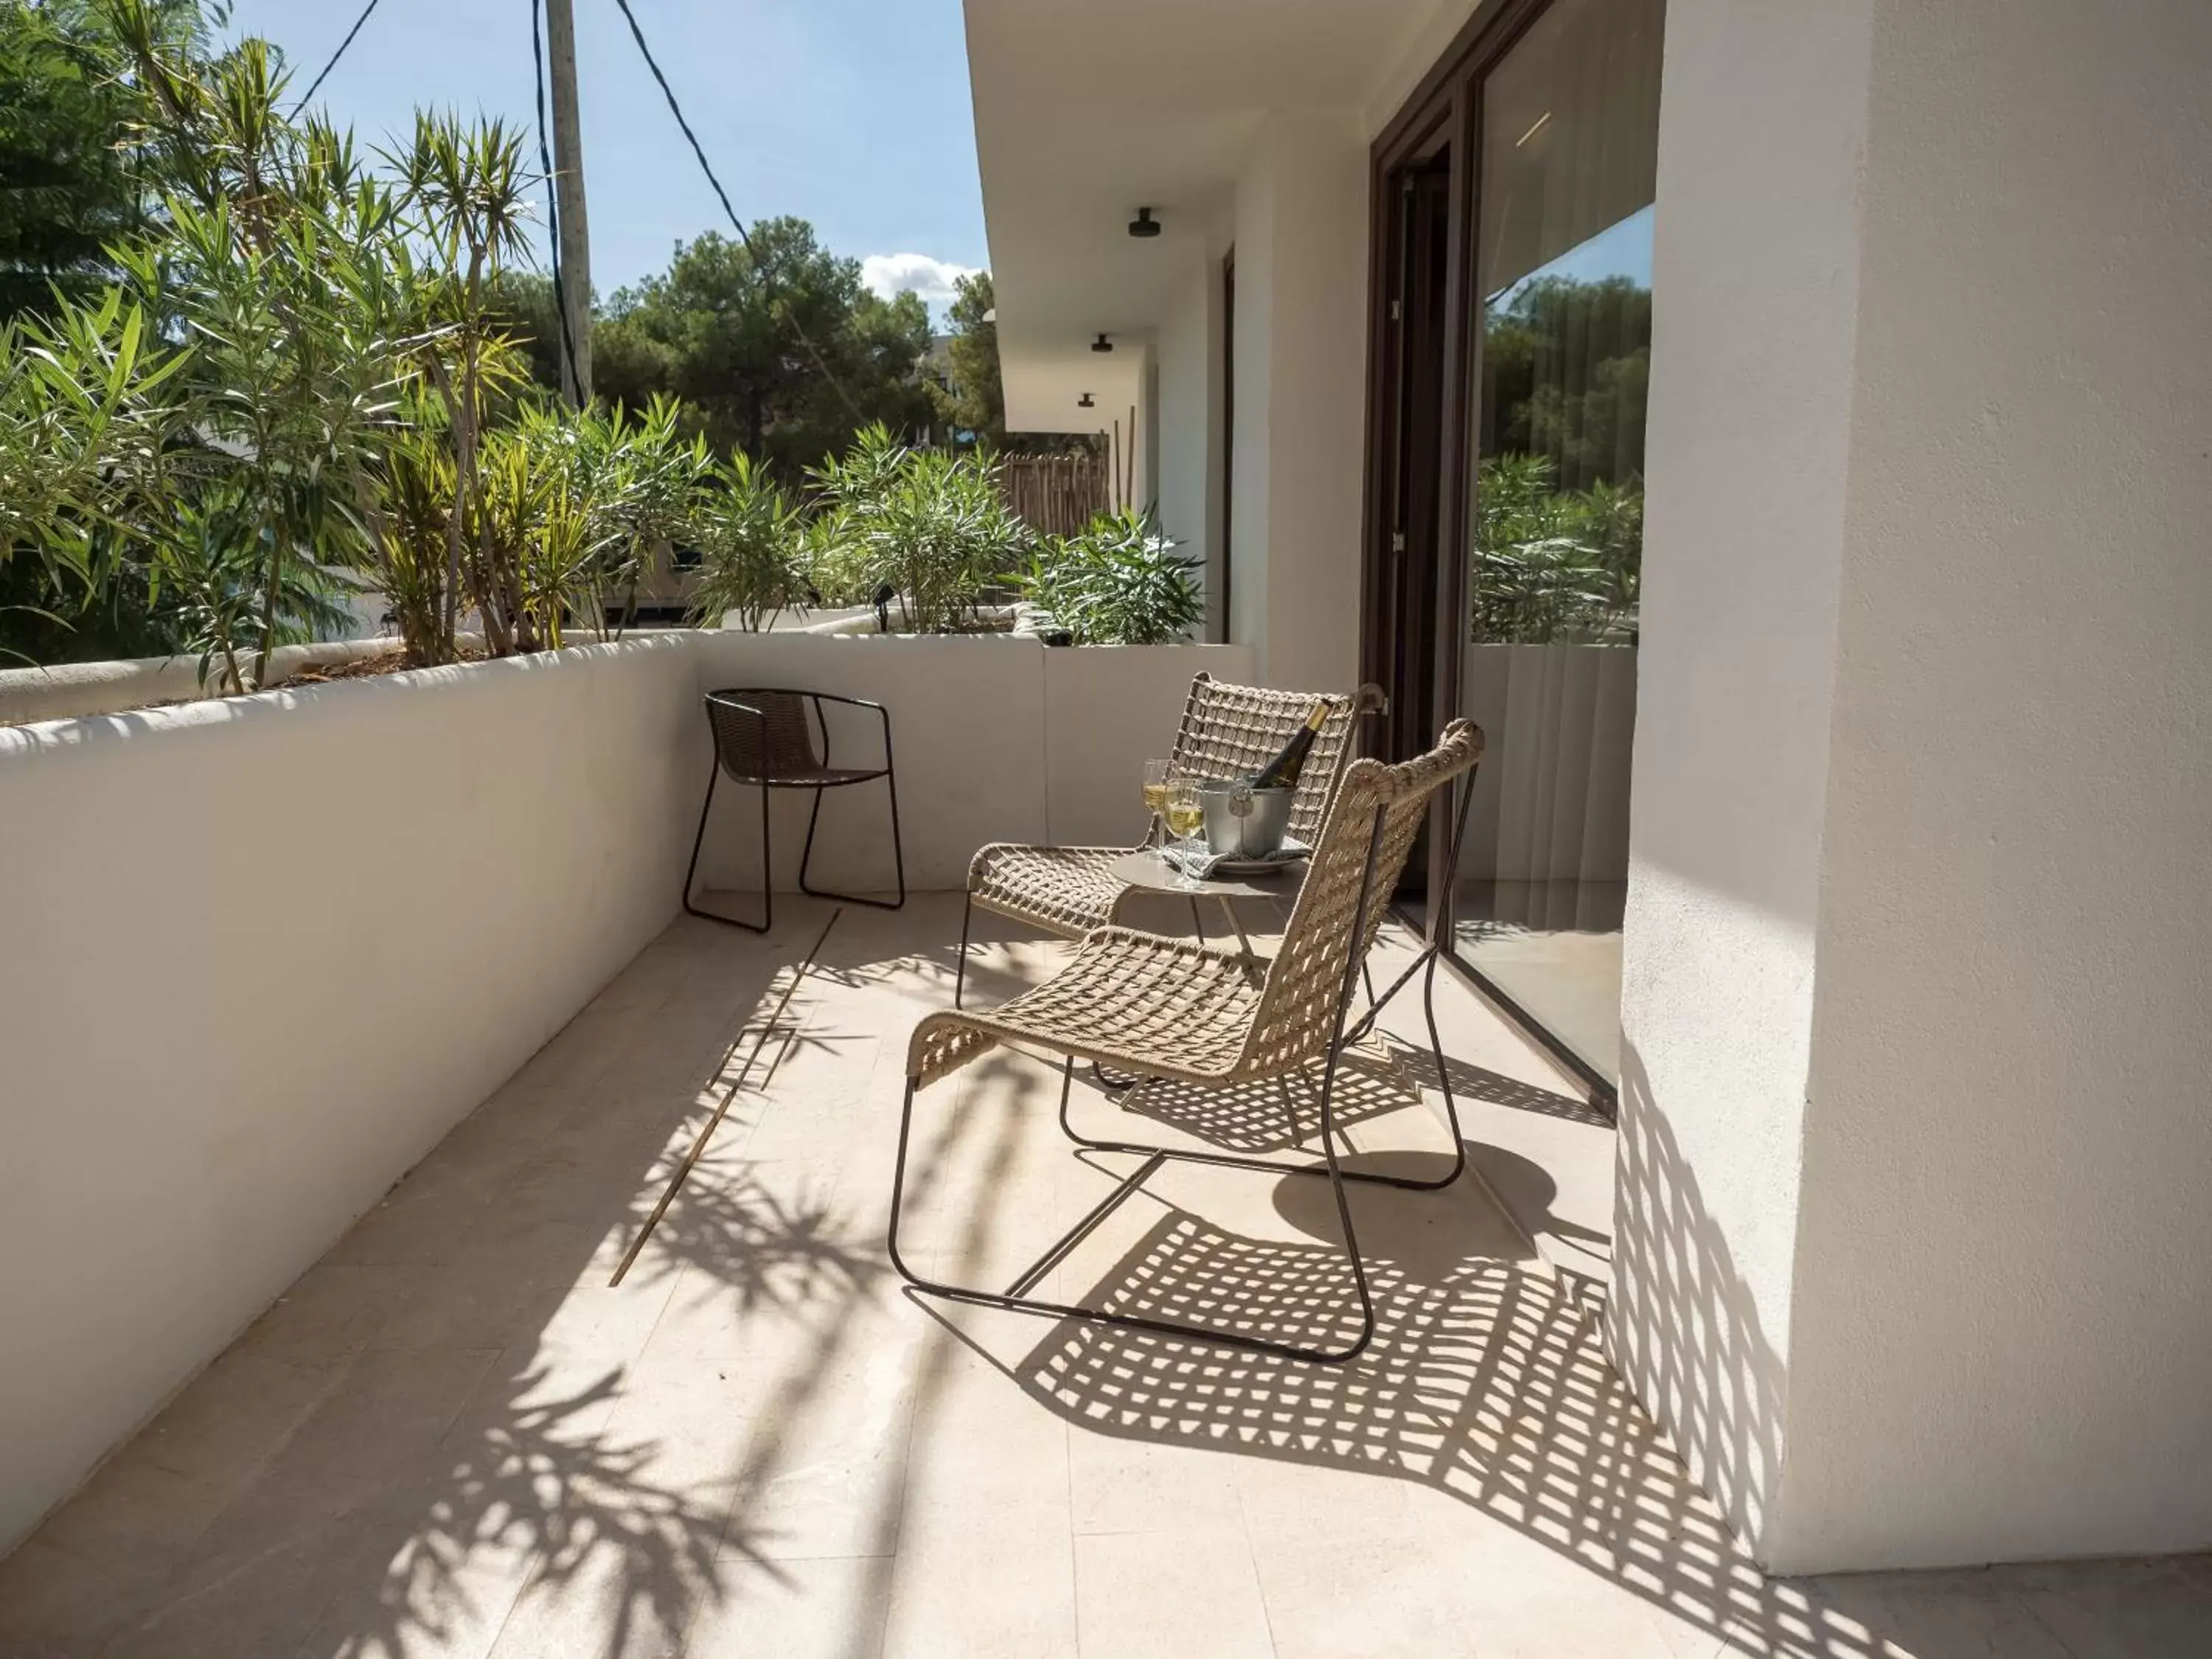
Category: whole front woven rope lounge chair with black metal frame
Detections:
[{"x1": 889, "y1": 721, "x2": 1482, "y2": 1365}]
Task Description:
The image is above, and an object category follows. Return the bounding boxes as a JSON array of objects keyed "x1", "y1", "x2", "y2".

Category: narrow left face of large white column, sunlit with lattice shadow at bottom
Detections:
[{"x1": 1608, "y1": 0, "x2": 1871, "y2": 1551}]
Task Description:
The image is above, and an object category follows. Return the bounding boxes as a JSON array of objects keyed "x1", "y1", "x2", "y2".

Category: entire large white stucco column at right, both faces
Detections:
[{"x1": 1608, "y1": 0, "x2": 2212, "y2": 1571}]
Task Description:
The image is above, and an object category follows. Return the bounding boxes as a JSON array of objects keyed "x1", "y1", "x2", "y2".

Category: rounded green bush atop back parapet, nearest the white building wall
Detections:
[{"x1": 1009, "y1": 509, "x2": 1206, "y2": 646}]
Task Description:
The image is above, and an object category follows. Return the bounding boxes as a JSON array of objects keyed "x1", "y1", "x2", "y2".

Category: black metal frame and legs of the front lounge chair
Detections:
[{"x1": 887, "y1": 770, "x2": 1475, "y2": 1365}]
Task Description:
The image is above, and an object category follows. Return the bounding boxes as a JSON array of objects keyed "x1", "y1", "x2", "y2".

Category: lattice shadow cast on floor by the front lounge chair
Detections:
[{"x1": 916, "y1": 1155, "x2": 1938, "y2": 1659}]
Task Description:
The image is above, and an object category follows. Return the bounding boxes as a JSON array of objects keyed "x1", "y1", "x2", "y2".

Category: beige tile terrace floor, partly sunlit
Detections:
[{"x1": 0, "y1": 896, "x2": 2212, "y2": 1659}]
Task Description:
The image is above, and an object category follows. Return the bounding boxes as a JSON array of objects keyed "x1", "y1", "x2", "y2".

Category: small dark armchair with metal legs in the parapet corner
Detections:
[{"x1": 684, "y1": 688, "x2": 907, "y2": 933}]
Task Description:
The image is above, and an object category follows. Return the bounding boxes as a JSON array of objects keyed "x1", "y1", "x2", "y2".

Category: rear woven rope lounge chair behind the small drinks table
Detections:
[{"x1": 953, "y1": 672, "x2": 1382, "y2": 1009}]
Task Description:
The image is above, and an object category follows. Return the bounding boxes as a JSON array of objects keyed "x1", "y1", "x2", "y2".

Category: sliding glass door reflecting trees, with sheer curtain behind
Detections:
[{"x1": 1369, "y1": 0, "x2": 1661, "y2": 1084}]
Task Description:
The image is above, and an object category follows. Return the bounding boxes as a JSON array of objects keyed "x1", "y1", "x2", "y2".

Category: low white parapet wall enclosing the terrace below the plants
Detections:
[{"x1": 0, "y1": 633, "x2": 1250, "y2": 1553}]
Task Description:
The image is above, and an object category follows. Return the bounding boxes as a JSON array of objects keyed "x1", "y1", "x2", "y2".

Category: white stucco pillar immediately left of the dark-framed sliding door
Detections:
[{"x1": 1230, "y1": 111, "x2": 1367, "y2": 690}]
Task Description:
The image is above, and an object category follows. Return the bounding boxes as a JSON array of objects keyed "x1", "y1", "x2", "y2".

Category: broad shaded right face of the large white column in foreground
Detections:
[{"x1": 1778, "y1": 0, "x2": 2212, "y2": 1566}]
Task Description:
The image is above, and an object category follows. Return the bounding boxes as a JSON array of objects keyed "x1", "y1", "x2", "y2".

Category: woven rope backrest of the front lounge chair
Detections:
[{"x1": 1239, "y1": 721, "x2": 1482, "y2": 1073}]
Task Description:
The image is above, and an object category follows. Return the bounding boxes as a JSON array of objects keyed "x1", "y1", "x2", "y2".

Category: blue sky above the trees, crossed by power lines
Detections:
[{"x1": 223, "y1": 0, "x2": 984, "y2": 316}]
